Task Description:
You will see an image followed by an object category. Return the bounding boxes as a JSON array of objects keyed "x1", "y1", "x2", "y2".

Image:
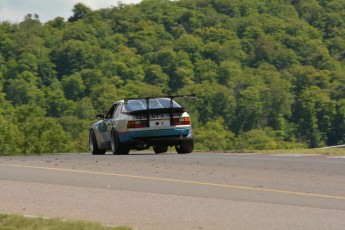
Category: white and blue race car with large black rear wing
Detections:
[{"x1": 89, "y1": 95, "x2": 194, "y2": 155}]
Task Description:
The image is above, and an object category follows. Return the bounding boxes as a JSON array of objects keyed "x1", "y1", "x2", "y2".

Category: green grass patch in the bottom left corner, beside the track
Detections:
[{"x1": 0, "y1": 214, "x2": 131, "y2": 230}]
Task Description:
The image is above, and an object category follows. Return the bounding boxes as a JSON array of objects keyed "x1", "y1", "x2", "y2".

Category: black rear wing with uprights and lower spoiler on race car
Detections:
[{"x1": 124, "y1": 94, "x2": 195, "y2": 125}]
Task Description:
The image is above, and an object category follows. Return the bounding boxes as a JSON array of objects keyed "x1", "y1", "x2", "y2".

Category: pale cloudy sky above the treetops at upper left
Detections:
[{"x1": 0, "y1": 0, "x2": 141, "y2": 23}]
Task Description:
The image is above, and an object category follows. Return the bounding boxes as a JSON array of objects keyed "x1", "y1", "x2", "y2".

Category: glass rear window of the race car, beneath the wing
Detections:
[{"x1": 123, "y1": 98, "x2": 182, "y2": 112}]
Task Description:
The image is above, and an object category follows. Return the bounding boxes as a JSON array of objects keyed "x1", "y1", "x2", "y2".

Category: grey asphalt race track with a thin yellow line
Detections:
[{"x1": 0, "y1": 152, "x2": 345, "y2": 230}]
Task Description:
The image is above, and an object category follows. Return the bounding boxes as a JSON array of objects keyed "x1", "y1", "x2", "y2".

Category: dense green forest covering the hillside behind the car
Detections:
[{"x1": 0, "y1": 0, "x2": 345, "y2": 155}]
